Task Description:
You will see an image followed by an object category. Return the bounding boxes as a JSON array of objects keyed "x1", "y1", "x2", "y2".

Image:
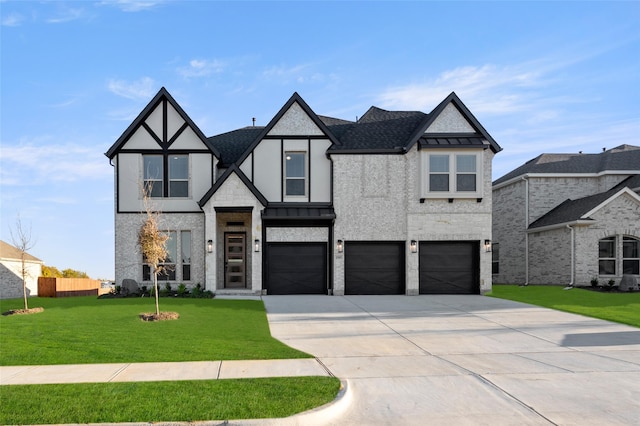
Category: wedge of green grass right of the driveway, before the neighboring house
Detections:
[{"x1": 487, "y1": 285, "x2": 640, "y2": 328}]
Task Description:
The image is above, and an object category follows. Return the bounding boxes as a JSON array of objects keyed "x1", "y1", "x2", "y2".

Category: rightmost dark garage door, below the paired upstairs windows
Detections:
[{"x1": 419, "y1": 241, "x2": 480, "y2": 294}]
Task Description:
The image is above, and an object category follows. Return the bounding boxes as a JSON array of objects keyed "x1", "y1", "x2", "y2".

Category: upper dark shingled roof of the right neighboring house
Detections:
[{"x1": 493, "y1": 145, "x2": 640, "y2": 185}]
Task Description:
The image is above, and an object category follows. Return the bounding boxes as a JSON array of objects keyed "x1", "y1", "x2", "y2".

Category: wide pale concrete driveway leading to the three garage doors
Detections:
[{"x1": 263, "y1": 295, "x2": 640, "y2": 426}]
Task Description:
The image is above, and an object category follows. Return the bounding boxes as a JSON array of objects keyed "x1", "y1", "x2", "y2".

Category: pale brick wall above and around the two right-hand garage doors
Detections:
[{"x1": 332, "y1": 147, "x2": 494, "y2": 295}]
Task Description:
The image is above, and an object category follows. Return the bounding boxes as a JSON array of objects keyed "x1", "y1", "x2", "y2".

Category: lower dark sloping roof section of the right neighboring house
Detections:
[{"x1": 529, "y1": 174, "x2": 640, "y2": 229}]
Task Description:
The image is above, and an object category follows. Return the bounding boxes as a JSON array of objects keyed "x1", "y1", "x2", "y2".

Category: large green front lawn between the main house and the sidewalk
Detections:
[{"x1": 0, "y1": 296, "x2": 310, "y2": 365}]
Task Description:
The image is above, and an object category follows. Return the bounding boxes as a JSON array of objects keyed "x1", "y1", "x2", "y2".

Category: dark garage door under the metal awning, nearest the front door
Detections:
[{"x1": 265, "y1": 243, "x2": 327, "y2": 294}]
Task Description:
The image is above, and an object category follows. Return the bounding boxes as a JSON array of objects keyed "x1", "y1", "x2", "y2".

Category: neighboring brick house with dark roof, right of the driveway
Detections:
[{"x1": 493, "y1": 145, "x2": 640, "y2": 286}]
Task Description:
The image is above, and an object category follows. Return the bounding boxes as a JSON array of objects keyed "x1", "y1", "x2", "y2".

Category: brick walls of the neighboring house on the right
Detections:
[{"x1": 493, "y1": 174, "x2": 640, "y2": 285}]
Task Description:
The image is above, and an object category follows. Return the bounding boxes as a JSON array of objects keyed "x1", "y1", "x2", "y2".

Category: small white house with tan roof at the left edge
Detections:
[{"x1": 0, "y1": 241, "x2": 43, "y2": 299}]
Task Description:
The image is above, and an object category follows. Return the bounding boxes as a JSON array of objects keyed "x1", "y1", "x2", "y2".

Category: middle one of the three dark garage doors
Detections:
[{"x1": 344, "y1": 241, "x2": 405, "y2": 294}]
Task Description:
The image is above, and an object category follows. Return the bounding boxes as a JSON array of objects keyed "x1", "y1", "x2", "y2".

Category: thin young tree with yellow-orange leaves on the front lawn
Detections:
[{"x1": 138, "y1": 187, "x2": 169, "y2": 315}]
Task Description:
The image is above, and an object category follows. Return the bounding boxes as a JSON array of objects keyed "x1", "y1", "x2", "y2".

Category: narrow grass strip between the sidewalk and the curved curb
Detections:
[{"x1": 0, "y1": 377, "x2": 340, "y2": 424}]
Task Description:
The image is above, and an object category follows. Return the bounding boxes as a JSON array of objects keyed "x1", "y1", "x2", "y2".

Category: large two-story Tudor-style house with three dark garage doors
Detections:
[{"x1": 105, "y1": 88, "x2": 501, "y2": 295}]
